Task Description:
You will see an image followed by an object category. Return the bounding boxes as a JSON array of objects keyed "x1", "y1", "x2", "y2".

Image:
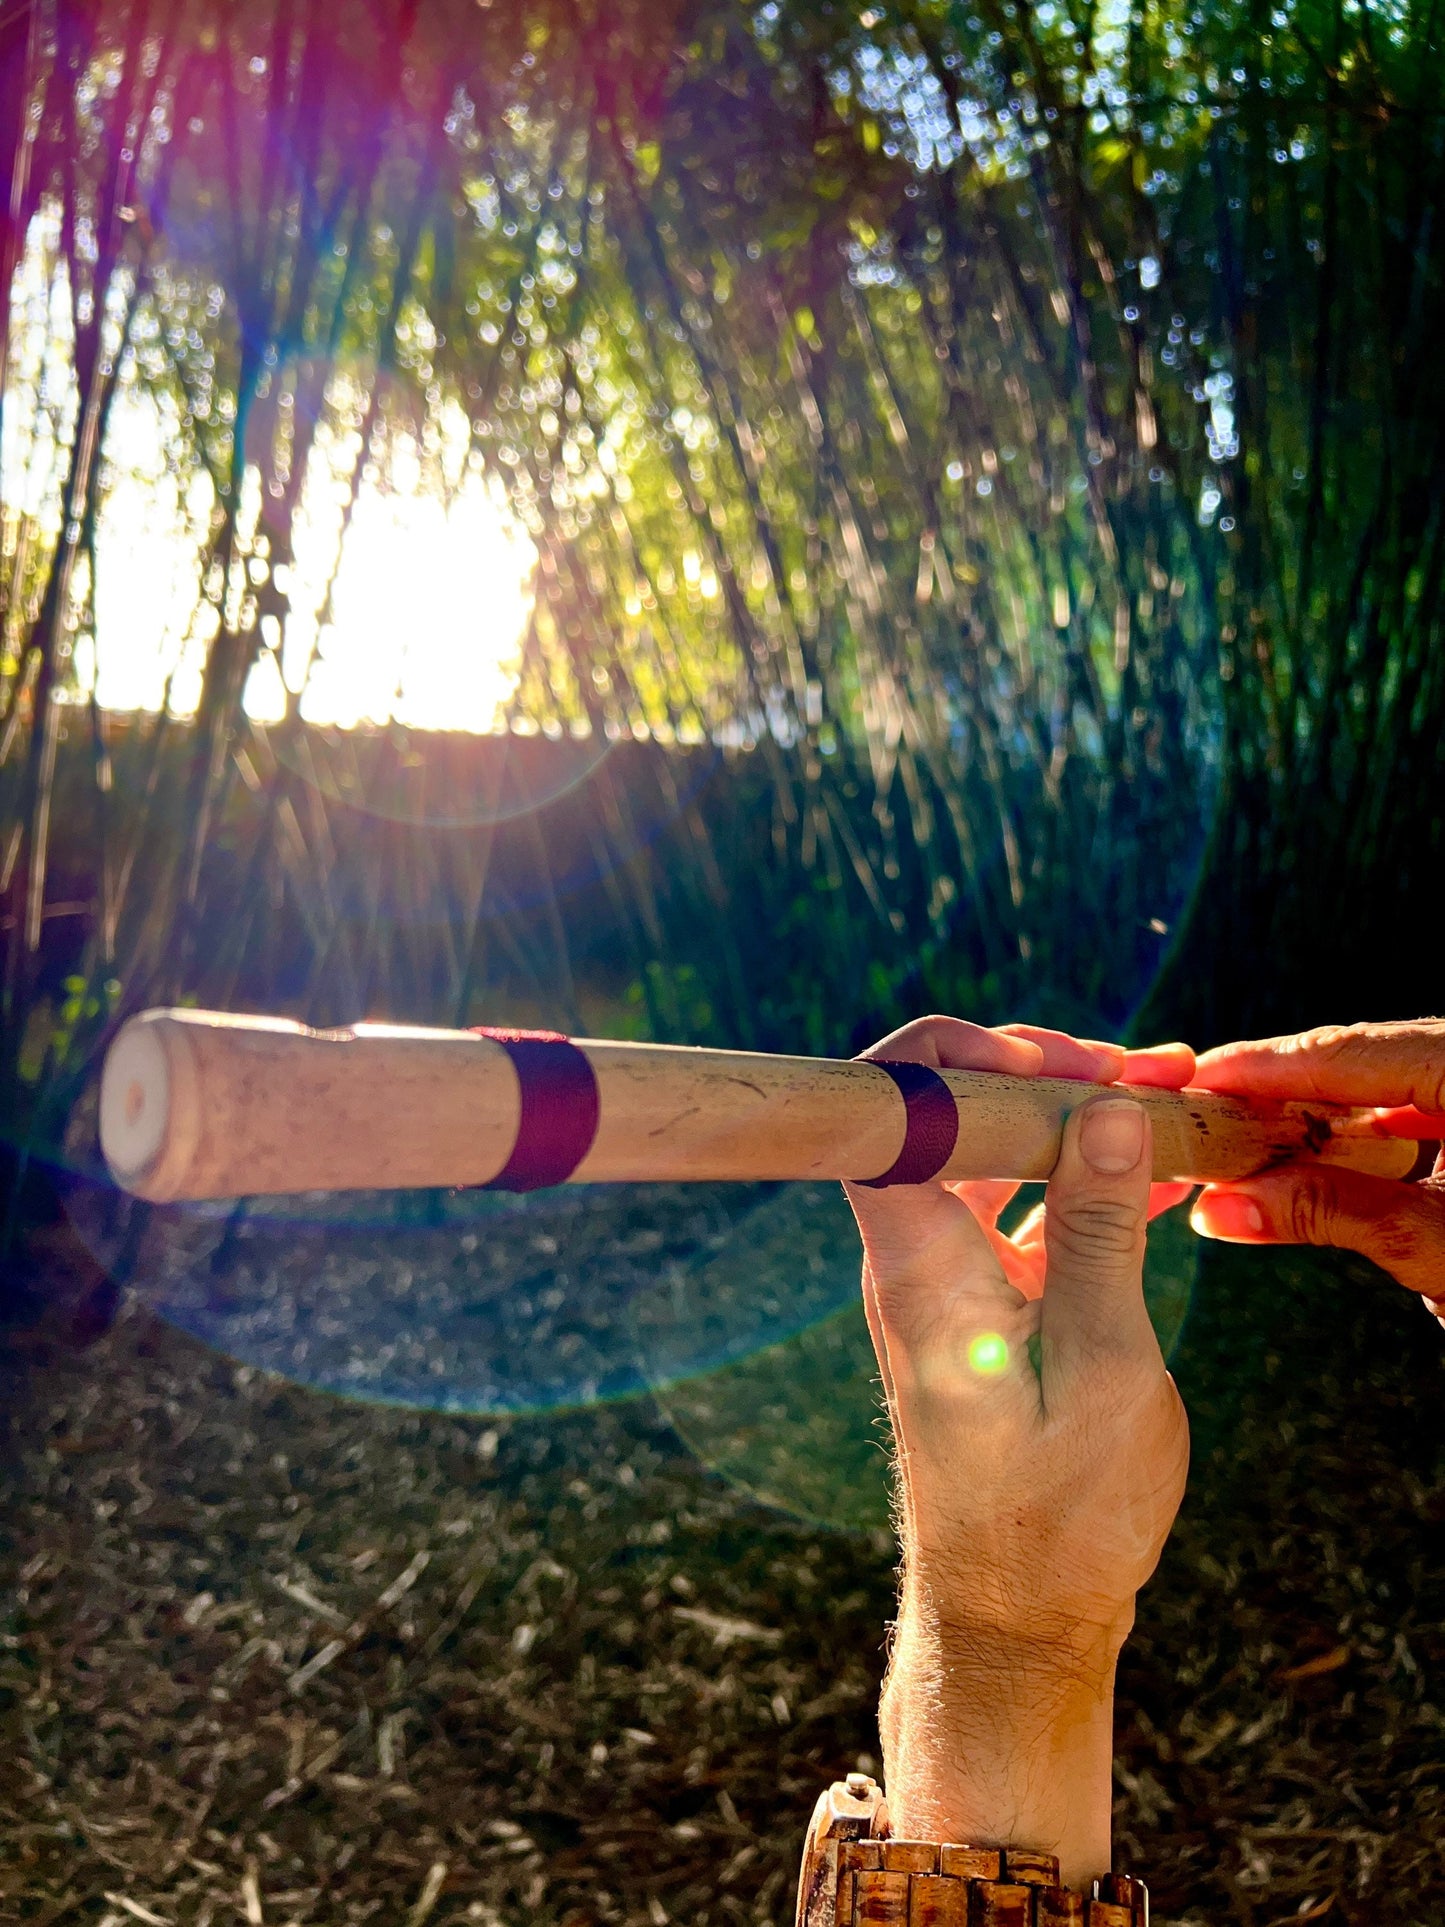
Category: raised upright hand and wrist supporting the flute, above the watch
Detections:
[{"x1": 846, "y1": 1017, "x2": 1193, "y2": 1883}]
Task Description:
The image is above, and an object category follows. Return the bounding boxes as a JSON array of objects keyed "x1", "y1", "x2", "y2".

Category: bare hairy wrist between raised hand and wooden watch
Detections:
[{"x1": 879, "y1": 1582, "x2": 1129, "y2": 1887}]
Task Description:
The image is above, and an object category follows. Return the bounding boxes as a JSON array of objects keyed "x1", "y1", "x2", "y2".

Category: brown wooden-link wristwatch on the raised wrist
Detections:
[{"x1": 798, "y1": 1773, "x2": 1148, "y2": 1927}]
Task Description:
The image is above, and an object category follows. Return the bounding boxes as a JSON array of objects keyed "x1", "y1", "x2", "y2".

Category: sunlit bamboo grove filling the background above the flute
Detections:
[{"x1": 0, "y1": 0, "x2": 1445, "y2": 1171}]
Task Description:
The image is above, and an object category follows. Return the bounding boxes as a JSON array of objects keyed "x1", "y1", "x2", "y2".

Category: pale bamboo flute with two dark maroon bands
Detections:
[{"x1": 100, "y1": 1010, "x2": 1420, "y2": 1202}]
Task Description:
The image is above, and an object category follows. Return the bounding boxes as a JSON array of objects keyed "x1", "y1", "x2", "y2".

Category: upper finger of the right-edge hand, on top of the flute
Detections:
[{"x1": 1195, "y1": 1017, "x2": 1445, "y2": 1114}]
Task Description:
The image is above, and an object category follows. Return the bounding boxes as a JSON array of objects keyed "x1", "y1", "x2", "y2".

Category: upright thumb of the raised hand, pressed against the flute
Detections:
[{"x1": 1044, "y1": 1096, "x2": 1158, "y2": 1368}]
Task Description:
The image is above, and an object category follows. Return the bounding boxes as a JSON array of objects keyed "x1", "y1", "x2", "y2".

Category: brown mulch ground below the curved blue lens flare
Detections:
[{"x1": 0, "y1": 1217, "x2": 1445, "y2": 1927}]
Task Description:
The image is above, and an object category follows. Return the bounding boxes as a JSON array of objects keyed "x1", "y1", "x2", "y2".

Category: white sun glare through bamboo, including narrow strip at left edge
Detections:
[{"x1": 0, "y1": 211, "x2": 536, "y2": 732}]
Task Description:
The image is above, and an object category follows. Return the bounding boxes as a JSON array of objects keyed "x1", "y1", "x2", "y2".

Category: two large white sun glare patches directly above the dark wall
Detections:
[{"x1": 91, "y1": 393, "x2": 534, "y2": 730}]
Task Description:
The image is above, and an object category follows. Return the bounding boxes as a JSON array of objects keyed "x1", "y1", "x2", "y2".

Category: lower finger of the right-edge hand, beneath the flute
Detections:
[{"x1": 1191, "y1": 1164, "x2": 1445, "y2": 1299}]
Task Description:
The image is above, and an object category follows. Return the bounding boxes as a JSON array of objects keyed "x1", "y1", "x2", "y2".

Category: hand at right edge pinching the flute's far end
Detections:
[{"x1": 1193, "y1": 1021, "x2": 1445, "y2": 1324}]
